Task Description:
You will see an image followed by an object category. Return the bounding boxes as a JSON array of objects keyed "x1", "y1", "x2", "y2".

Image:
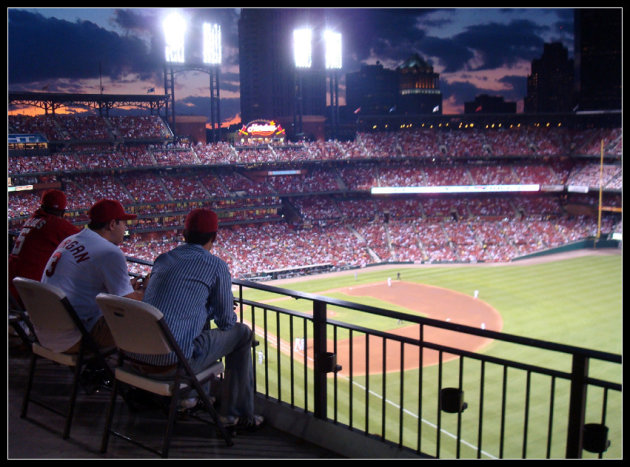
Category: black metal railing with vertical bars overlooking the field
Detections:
[{"x1": 233, "y1": 279, "x2": 622, "y2": 458}]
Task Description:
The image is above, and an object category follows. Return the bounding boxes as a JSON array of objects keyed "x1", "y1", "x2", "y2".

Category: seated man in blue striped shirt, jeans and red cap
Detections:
[{"x1": 138, "y1": 209, "x2": 263, "y2": 428}]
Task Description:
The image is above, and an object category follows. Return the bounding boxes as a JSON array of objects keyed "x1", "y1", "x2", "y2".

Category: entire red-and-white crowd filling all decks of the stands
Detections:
[{"x1": 8, "y1": 116, "x2": 622, "y2": 277}]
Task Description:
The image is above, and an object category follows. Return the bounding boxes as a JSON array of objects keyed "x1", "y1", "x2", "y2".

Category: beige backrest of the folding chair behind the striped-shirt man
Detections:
[{"x1": 96, "y1": 293, "x2": 173, "y2": 355}]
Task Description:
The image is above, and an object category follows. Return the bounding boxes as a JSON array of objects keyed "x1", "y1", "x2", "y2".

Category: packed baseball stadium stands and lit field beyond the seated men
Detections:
[{"x1": 8, "y1": 101, "x2": 623, "y2": 459}]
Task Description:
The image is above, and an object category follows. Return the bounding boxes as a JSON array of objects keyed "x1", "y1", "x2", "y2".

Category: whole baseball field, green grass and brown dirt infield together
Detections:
[{"x1": 239, "y1": 250, "x2": 623, "y2": 459}]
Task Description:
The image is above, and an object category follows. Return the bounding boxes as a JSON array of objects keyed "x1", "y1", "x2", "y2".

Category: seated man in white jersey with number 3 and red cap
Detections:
[{"x1": 36, "y1": 199, "x2": 143, "y2": 352}]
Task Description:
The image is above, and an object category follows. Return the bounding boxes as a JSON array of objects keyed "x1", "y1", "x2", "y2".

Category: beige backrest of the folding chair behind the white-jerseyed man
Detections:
[{"x1": 13, "y1": 277, "x2": 82, "y2": 352}]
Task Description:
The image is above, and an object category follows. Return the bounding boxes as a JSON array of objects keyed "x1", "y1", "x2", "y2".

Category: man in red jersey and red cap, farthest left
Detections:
[{"x1": 9, "y1": 189, "x2": 81, "y2": 305}]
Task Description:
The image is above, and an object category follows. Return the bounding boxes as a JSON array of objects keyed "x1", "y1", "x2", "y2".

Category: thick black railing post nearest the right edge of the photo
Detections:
[{"x1": 566, "y1": 354, "x2": 588, "y2": 459}]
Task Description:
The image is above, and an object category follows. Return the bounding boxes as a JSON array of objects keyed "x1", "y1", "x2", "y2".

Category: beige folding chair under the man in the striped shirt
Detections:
[{"x1": 96, "y1": 293, "x2": 233, "y2": 457}]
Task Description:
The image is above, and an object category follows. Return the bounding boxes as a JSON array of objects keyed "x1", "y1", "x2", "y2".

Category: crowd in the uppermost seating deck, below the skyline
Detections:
[{"x1": 9, "y1": 115, "x2": 622, "y2": 173}]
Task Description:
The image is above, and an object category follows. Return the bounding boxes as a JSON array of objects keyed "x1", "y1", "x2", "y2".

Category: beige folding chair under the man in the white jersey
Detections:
[{"x1": 13, "y1": 277, "x2": 116, "y2": 439}]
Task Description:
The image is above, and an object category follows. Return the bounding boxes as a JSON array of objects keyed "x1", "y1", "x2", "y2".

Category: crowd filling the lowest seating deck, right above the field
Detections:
[{"x1": 115, "y1": 195, "x2": 620, "y2": 277}]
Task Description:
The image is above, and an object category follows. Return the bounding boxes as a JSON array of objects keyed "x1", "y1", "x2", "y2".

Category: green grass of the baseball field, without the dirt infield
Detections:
[{"x1": 245, "y1": 255, "x2": 622, "y2": 458}]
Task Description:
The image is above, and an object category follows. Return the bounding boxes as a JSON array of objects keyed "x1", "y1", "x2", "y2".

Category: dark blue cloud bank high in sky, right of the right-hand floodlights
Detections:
[{"x1": 329, "y1": 8, "x2": 560, "y2": 77}]
